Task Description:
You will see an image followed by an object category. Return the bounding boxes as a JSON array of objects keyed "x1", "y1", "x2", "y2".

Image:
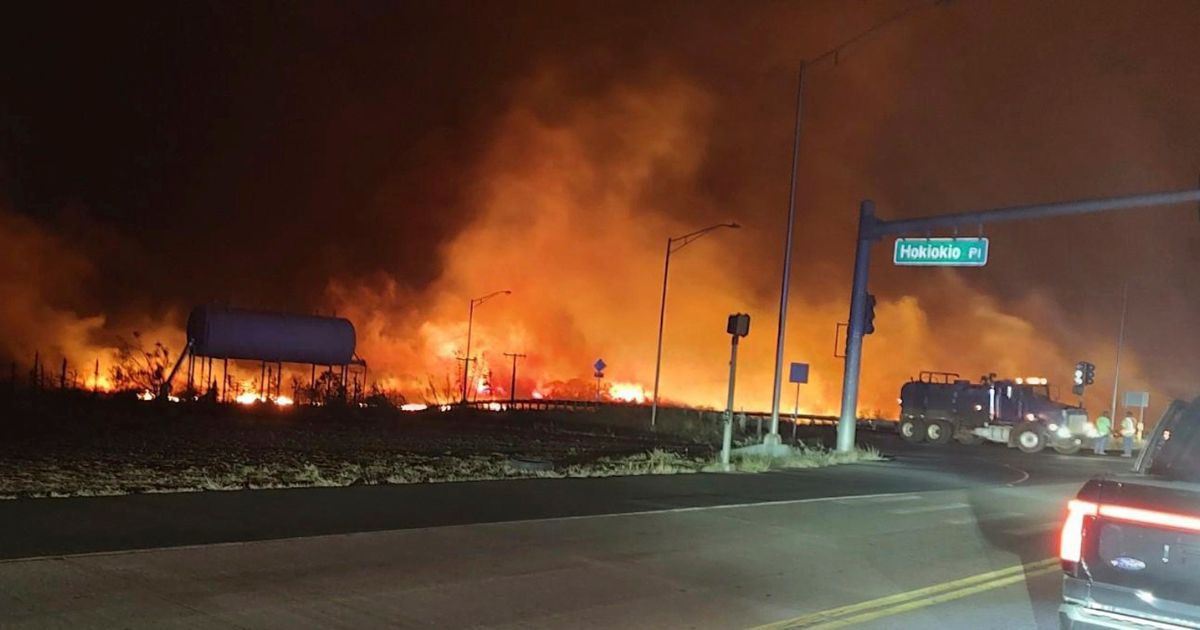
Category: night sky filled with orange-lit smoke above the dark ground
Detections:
[{"x1": 0, "y1": 0, "x2": 1200, "y2": 415}]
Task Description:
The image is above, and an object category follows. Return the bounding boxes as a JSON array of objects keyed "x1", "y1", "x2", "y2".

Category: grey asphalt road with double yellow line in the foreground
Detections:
[{"x1": 0, "y1": 429, "x2": 1128, "y2": 629}]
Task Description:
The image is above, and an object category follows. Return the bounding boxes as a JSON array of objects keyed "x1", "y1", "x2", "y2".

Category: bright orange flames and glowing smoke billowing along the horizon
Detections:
[{"x1": 0, "y1": 68, "x2": 1171, "y2": 416}]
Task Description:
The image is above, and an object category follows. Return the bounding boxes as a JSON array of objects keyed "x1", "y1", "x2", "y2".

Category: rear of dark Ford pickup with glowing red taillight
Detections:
[{"x1": 1058, "y1": 398, "x2": 1200, "y2": 629}]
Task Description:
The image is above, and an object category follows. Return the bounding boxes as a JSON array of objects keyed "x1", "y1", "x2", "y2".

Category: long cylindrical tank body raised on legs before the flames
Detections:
[{"x1": 187, "y1": 305, "x2": 355, "y2": 365}]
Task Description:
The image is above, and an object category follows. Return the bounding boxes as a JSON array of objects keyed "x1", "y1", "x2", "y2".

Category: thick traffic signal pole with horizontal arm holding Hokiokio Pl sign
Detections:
[{"x1": 838, "y1": 190, "x2": 1200, "y2": 452}]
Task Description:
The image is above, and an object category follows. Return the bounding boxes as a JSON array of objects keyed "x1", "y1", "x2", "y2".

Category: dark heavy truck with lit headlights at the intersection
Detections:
[{"x1": 898, "y1": 372, "x2": 1096, "y2": 455}]
